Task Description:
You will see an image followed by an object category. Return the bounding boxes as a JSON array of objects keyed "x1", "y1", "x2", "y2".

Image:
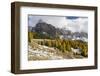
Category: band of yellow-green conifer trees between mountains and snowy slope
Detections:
[{"x1": 28, "y1": 33, "x2": 88, "y2": 57}]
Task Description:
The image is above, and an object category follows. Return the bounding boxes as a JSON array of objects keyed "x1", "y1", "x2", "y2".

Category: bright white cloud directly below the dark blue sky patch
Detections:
[{"x1": 66, "y1": 17, "x2": 88, "y2": 32}]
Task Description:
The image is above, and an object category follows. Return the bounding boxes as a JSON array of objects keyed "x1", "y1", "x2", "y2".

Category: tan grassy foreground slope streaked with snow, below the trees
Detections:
[{"x1": 28, "y1": 42, "x2": 73, "y2": 60}]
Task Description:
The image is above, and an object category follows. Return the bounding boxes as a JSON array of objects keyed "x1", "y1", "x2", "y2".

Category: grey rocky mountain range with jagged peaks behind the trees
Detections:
[{"x1": 29, "y1": 20, "x2": 88, "y2": 39}]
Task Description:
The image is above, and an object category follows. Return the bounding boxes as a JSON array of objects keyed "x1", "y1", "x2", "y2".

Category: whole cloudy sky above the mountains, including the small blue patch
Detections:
[{"x1": 28, "y1": 15, "x2": 88, "y2": 32}]
